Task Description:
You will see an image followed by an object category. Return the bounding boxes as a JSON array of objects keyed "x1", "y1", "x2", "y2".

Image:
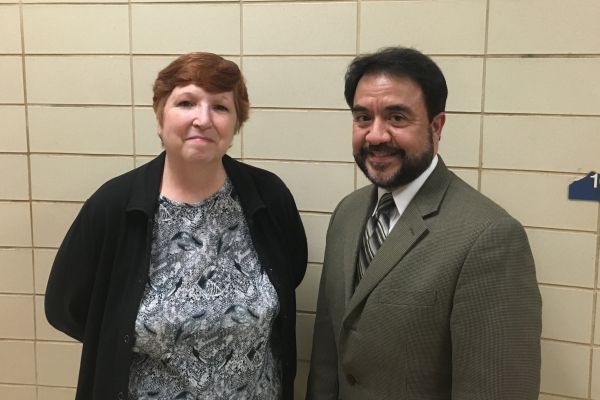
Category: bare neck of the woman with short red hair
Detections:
[{"x1": 160, "y1": 155, "x2": 227, "y2": 203}]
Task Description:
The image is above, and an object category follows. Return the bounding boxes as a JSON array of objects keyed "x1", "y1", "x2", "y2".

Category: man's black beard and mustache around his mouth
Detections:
[{"x1": 354, "y1": 129, "x2": 434, "y2": 190}]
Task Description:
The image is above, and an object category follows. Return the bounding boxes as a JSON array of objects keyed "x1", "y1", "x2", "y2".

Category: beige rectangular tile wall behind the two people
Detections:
[{"x1": 0, "y1": 0, "x2": 600, "y2": 400}]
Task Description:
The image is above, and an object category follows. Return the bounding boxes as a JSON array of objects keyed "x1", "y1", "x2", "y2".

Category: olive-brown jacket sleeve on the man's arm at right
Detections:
[{"x1": 450, "y1": 217, "x2": 541, "y2": 400}]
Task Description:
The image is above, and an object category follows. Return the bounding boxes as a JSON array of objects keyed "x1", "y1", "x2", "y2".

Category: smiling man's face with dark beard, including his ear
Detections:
[{"x1": 352, "y1": 73, "x2": 446, "y2": 189}]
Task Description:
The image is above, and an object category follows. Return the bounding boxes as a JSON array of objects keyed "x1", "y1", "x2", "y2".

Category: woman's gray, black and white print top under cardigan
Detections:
[{"x1": 129, "y1": 180, "x2": 281, "y2": 400}]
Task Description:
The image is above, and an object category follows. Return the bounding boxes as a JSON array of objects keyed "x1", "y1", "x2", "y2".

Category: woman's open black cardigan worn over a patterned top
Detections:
[{"x1": 45, "y1": 153, "x2": 307, "y2": 400}]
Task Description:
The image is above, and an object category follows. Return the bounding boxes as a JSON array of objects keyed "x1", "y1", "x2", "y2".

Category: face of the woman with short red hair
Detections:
[{"x1": 160, "y1": 84, "x2": 237, "y2": 164}]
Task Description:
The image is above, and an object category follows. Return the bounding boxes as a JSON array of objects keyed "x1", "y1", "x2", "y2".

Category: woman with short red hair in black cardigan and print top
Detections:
[{"x1": 45, "y1": 53, "x2": 307, "y2": 400}]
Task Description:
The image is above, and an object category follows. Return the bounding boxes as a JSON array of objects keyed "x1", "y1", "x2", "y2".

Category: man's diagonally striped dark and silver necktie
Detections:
[{"x1": 356, "y1": 193, "x2": 395, "y2": 284}]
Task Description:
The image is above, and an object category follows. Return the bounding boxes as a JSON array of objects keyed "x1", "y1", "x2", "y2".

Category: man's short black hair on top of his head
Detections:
[{"x1": 344, "y1": 47, "x2": 448, "y2": 121}]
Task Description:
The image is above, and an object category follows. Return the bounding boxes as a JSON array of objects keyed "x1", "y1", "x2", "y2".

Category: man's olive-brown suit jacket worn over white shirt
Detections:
[{"x1": 307, "y1": 159, "x2": 541, "y2": 400}]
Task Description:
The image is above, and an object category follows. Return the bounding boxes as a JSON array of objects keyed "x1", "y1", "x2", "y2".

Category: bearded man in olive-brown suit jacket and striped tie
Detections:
[{"x1": 307, "y1": 48, "x2": 541, "y2": 400}]
